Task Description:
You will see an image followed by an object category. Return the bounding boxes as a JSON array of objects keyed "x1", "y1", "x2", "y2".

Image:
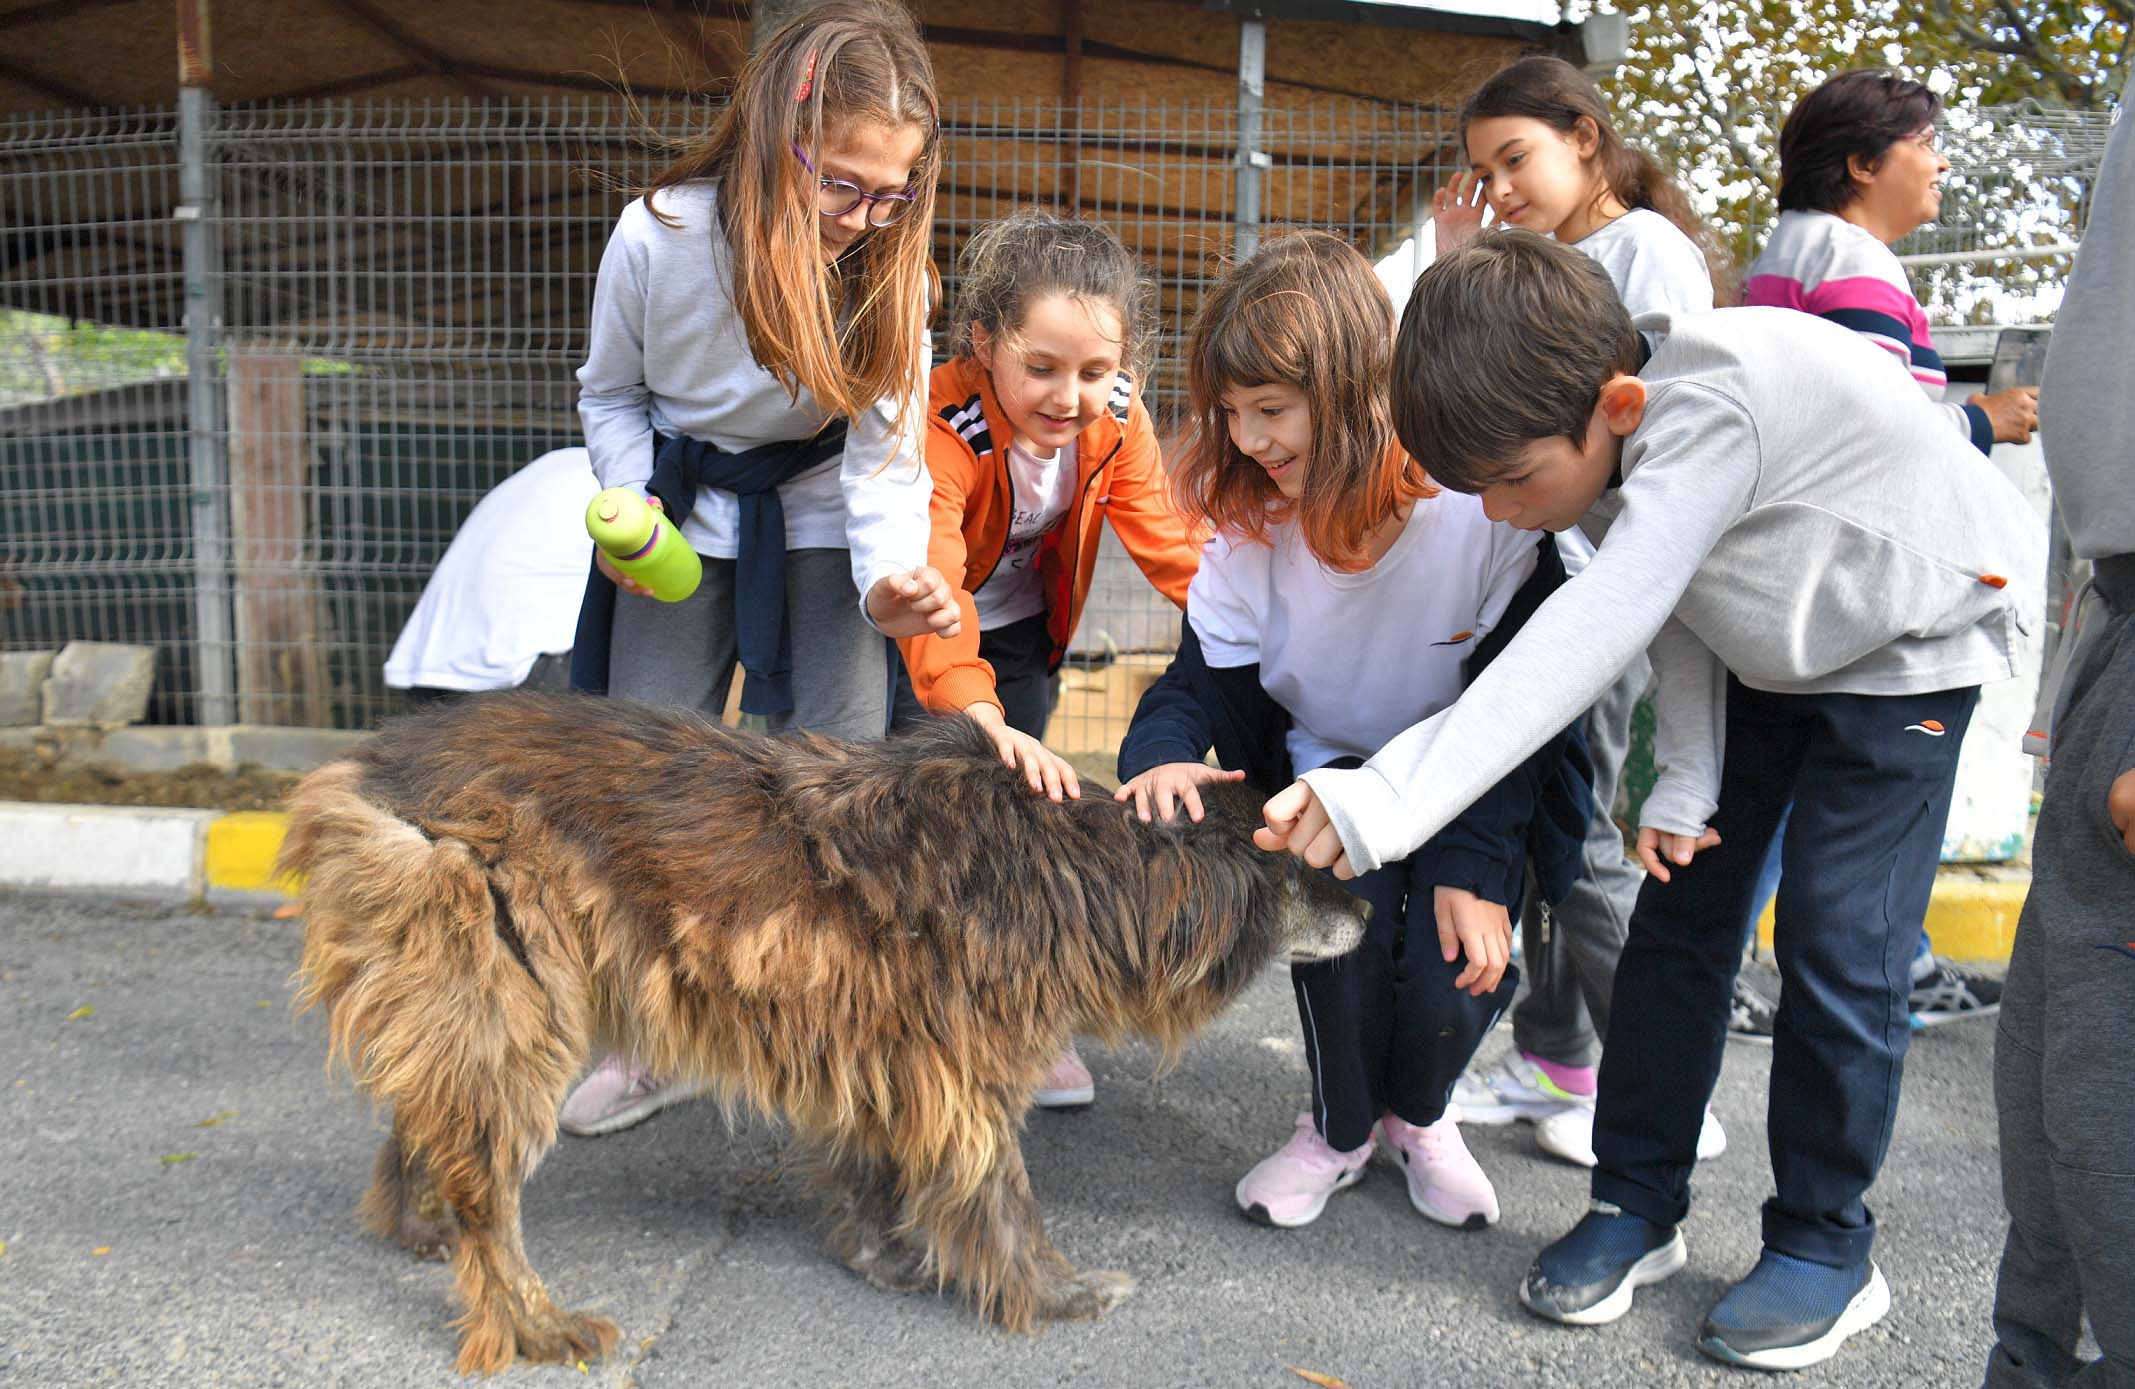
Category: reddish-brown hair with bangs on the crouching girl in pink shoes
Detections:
[{"x1": 1172, "y1": 230, "x2": 1437, "y2": 574}]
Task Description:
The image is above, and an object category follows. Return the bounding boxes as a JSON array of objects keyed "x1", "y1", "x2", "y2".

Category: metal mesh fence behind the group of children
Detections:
[{"x1": 0, "y1": 98, "x2": 2103, "y2": 751}]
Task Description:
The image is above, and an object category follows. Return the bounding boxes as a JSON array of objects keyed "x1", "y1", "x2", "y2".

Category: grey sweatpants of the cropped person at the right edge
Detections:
[{"x1": 1986, "y1": 585, "x2": 2135, "y2": 1389}]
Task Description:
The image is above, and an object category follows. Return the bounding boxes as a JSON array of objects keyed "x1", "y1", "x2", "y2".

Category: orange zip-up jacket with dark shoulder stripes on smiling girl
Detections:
[{"x1": 899, "y1": 356, "x2": 1202, "y2": 713}]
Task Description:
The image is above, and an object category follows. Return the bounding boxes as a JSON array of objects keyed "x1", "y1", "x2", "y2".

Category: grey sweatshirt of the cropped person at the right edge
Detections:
[{"x1": 2039, "y1": 117, "x2": 2135, "y2": 559}]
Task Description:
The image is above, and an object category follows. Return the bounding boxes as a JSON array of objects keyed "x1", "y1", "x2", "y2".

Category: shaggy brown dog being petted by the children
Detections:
[{"x1": 282, "y1": 696, "x2": 1364, "y2": 1372}]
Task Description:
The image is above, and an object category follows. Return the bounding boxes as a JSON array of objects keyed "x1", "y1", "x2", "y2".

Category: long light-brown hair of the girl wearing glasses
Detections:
[{"x1": 645, "y1": 0, "x2": 942, "y2": 431}]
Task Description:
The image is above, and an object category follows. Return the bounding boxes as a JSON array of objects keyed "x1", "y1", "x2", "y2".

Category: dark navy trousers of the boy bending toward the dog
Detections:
[{"x1": 1593, "y1": 676, "x2": 1979, "y2": 1267}]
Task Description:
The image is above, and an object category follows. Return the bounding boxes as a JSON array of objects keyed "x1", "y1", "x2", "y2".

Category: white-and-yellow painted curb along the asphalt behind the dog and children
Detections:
[{"x1": 0, "y1": 800, "x2": 2030, "y2": 962}]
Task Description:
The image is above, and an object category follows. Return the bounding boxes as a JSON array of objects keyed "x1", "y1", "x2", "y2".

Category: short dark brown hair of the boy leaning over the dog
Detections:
[{"x1": 1392, "y1": 228, "x2": 1638, "y2": 493}]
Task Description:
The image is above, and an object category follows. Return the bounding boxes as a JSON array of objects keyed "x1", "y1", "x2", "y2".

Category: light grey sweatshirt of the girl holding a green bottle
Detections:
[{"x1": 579, "y1": 183, "x2": 933, "y2": 597}]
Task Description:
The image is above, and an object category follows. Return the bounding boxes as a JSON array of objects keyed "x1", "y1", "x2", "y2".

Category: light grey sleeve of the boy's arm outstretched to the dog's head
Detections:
[{"x1": 1302, "y1": 380, "x2": 1759, "y2": 873}]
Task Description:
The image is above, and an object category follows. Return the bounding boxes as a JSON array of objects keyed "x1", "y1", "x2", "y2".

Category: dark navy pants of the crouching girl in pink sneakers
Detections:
[{"x1": 1290, "y1": 858, "x2": 1520, "y2": 1152}]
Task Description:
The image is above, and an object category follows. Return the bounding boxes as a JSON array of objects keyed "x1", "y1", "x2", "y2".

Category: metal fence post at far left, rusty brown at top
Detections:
[{"x1": 173, "y1": 0, "x2": 237, "y2": 725}]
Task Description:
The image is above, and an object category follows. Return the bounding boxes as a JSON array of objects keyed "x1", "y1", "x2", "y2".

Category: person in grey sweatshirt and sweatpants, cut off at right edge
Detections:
[{"x1": 1986, "y1": 119, "x2": 2135, "y2": 1389}]
